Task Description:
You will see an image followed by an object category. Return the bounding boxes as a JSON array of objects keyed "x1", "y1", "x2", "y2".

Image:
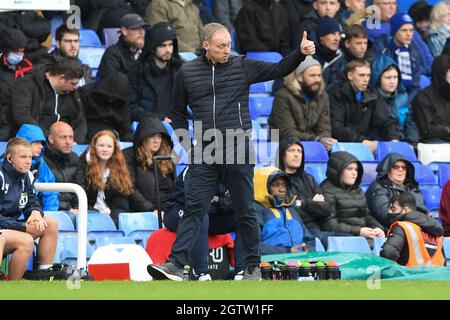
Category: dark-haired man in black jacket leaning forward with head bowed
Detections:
[{"x1": 11, "y1": 59, "x2": 87, "y2": 143}]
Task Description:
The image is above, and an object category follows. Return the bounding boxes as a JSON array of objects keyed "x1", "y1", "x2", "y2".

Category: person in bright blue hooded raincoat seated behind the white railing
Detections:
[{"x1": 16, "y1": 124, "x2": 59, "y2": 211}]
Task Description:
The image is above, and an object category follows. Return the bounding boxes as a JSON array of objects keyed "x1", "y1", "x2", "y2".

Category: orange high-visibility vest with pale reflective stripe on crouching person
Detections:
[{"x1": 388, "y1": 221, "x2": 445, "y2": 267}]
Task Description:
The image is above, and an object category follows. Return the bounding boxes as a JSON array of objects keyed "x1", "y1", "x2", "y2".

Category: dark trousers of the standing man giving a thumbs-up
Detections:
[{"x1": 169, "y1": 164, "x2": 261, "y2": 268}]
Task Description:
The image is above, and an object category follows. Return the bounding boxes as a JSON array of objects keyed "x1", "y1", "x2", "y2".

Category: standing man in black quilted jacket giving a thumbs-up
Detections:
[{"x1": 148, "y1": 23, "x2": 315, "y2": 281}]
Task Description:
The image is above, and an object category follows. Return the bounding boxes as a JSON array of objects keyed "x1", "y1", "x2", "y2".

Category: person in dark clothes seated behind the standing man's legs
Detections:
[{"x1": 164, "y1": 167, "x2": 238, "y2": 281}]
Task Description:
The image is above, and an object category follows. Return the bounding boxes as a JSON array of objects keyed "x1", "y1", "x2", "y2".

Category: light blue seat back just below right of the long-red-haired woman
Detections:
[{"x1": 119, "y1": 212, "x2": 159, "y2": 236}]
